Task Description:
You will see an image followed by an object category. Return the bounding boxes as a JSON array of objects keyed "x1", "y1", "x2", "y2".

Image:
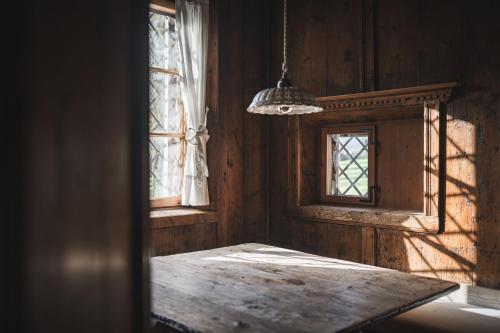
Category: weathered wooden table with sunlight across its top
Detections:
[{"x1": 151, "y1": 244, "x2": 458, "y2": 333}]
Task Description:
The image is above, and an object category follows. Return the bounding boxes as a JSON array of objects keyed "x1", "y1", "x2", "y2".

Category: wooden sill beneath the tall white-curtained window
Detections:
[{"x1": 149, "y1": 207, "x2": 217, "y2": 229}]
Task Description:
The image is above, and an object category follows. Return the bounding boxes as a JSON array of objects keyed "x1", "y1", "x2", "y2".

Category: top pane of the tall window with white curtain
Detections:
[{"x1": 149, "y1": 13, "x2": 179, "y2": 70}]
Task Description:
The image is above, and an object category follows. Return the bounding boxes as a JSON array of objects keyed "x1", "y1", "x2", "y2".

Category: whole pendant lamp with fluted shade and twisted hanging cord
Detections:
[{"x1": 247, "y1": 0, "x2": 323, "y2": 115}]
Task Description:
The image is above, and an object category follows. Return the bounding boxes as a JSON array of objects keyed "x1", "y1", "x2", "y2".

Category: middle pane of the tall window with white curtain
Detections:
[{"x1": 149, "y1": 73, "x2": 182, "y2": 133}]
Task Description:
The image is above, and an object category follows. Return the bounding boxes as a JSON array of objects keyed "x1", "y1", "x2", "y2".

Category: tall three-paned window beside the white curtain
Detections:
[{"x1": 149, "y1": 11, "x2": 186, "y2": 208}]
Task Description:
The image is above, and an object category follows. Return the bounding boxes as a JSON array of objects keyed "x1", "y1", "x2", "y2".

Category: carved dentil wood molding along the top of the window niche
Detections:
[{"x1": 316, "y1": 82, "x2": 458, "y2": 112}]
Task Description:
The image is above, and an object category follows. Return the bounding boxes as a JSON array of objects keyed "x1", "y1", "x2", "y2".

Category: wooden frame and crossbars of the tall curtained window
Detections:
[{"x1": 148, "y1": 0, "x2": 187, "y2": 209}]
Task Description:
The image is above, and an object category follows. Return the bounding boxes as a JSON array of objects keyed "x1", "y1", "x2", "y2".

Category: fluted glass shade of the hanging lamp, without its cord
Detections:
[{"x1": 247, "y1": 85, "x2": 323, "y2": 115}]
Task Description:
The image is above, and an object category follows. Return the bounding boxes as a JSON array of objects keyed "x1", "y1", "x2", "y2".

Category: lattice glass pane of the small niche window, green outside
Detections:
[{"x1": 330, "y1": 133, "x2": 368, "y2": 197}]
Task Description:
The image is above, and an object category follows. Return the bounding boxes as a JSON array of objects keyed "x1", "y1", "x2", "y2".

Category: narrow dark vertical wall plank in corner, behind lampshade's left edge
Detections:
[{"x1": 241, "y1": 1, "x2": 269, "y2": 242}]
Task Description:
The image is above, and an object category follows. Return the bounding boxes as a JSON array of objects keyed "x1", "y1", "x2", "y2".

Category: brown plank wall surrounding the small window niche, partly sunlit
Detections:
[{"x1": 269, "y1": 0, "x2": 500, "y2": 288}]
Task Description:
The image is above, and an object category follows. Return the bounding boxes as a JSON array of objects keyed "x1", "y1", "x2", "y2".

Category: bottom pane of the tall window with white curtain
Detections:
[{"x1": 149, "y1": 136, "x2": 182, "y2": 199}]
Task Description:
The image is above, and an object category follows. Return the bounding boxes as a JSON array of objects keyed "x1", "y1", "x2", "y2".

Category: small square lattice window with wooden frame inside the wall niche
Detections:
[{"x1": 321, "y1": 126, "x2": 376, "y2": 205}]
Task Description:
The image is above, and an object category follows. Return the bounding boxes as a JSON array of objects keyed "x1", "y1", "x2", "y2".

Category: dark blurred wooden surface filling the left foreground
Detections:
[{"x1": 0, "y1": 0, "x2": 149, "y2": 333}]
